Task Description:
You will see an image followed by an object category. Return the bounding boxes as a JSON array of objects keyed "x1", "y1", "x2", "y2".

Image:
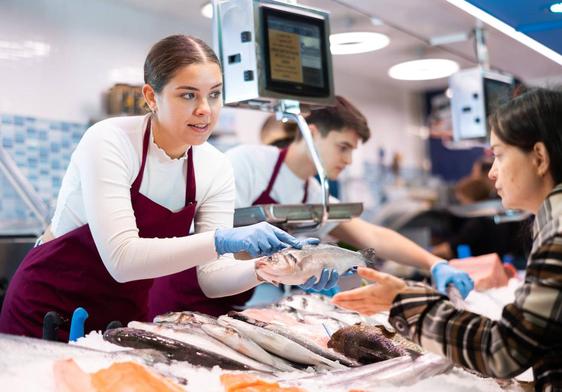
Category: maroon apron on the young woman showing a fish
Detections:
[{"x1": 0, "y1": 119, "x2": 196, "y2": 340}]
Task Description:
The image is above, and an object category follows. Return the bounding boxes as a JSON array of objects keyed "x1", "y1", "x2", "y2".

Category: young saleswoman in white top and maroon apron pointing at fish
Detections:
[{"x1": 0, "y1": 35, "x2": 316, "y2": 339}]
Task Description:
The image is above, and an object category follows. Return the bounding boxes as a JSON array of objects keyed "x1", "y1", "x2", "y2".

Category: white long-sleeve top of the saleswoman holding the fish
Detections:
[{"x1": 51, "y1": 116, "x2": 258, "y2": 297}]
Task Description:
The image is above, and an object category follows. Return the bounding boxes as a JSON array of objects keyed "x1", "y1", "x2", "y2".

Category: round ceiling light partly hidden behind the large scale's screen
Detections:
[{"x1": 330, "y1": 32, "x2": 390, "y2": 54}]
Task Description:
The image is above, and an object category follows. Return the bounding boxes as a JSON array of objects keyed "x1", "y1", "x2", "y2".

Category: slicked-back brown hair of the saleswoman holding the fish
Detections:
[{"x1": 144, "y1": 35, "x2": 220, "y2": 93}]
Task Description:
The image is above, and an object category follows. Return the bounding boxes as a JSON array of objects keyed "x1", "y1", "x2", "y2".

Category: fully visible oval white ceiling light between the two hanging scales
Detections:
[{"x1": 388, "y1": 59, "x2": 459, "y2": 80}]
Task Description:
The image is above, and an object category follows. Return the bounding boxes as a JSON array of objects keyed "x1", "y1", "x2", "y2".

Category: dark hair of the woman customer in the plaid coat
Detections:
[{"x1": 489, "y1": 88, "x2": 562, "y2": 184}]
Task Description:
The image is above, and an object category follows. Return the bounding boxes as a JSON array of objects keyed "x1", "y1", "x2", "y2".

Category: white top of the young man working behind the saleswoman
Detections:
[{"x1": 226, "y1": 145, "x2": 339, "y2": 237}]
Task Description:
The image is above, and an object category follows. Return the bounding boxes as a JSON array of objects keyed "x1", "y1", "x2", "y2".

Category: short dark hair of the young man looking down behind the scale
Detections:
[{"x1": 295, "y1": 96, "x2": 371, "y2": 142}]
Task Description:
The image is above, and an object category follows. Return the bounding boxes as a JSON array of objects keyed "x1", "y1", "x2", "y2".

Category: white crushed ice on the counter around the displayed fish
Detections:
[{"x1": 0, "y1": 280, "x2": 528, "y2": 392}]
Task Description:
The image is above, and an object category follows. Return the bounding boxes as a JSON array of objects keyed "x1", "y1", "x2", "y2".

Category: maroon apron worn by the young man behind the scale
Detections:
[{"x1": 149, "y1": 149, "x2": 307, "y2": 319}]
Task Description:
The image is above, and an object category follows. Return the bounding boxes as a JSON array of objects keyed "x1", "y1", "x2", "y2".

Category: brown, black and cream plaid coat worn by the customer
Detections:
[{"x1": 390, "y1": 184, "x2": 562, "y2": 391}]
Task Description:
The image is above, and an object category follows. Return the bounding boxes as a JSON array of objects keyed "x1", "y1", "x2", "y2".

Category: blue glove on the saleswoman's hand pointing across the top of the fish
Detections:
[{"x1": 215, "y1": 222, "x2": 310, "y2": 257}]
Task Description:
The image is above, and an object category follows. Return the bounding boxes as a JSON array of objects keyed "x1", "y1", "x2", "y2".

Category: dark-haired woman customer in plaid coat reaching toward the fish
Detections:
[{"x1": 333, "y1": 89, "x2": 562, "y2": 391}]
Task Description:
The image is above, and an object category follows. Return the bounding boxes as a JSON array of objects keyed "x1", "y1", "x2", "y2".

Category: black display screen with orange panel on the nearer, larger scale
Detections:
[{"x1": 261, "y1": 7, "x2": 330, "y2": 97}]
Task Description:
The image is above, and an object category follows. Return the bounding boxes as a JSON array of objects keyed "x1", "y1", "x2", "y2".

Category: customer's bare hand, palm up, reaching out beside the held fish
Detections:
[{"x1": 332, "y1": 267, "x2": 407, "y2": 316}]
